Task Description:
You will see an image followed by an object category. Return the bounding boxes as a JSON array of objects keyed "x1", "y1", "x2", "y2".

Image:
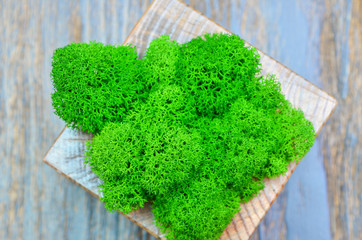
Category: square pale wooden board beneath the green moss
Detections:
[{"x1": 44, "y1": 0, "x2": 337, "y2": 239}]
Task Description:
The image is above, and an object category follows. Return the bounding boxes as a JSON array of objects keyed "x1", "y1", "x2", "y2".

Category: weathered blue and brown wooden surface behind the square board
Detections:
[{"x1": 0, "y1": 0, "x2": 362, "y2": 239}]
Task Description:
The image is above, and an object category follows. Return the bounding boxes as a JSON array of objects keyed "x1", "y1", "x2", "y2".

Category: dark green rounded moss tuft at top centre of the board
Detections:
[{"x1": 176, "y1": 34, "x2": 260, "y2": 118}]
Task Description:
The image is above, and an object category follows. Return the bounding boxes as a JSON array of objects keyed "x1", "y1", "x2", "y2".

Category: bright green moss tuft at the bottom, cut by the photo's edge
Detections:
[{"x1": 153, "y1": 179, "x2": 240, "y2": 240}]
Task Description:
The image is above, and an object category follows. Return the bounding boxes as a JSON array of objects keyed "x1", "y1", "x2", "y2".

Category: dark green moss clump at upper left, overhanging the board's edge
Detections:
[{"x1": 51, "y1": 42, "x2": 145, "y2": 133}]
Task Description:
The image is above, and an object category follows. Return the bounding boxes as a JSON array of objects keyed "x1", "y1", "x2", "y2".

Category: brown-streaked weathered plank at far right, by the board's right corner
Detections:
[{"x1": 321, "y1": 0, "x2": 362, "y2": 239}]
